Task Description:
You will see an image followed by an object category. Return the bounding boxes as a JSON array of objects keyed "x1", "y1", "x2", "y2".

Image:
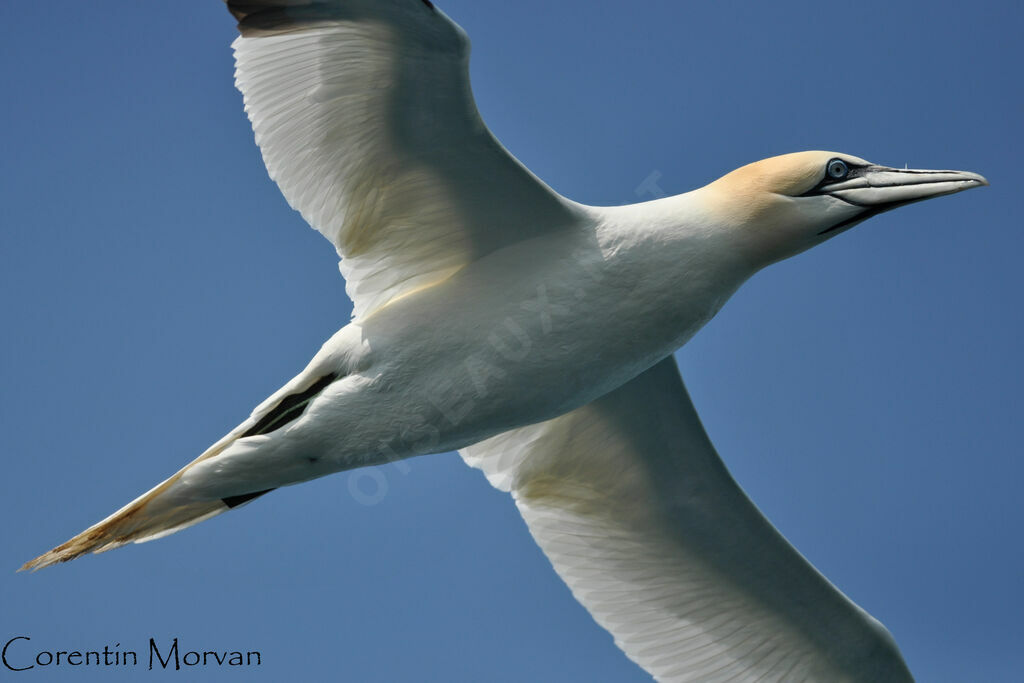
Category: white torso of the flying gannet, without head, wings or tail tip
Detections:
[{"x1": 153, "y1": 188, "x2": 753, "y2": 499}]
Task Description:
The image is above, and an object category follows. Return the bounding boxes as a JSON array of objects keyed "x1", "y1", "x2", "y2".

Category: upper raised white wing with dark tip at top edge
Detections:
[{"x1": 226, "y1": 0, "x2": 571, "y2": 317}]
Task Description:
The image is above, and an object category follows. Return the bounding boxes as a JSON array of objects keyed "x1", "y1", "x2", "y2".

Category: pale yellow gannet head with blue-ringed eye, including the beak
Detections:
[{"x1": 703, "y1": 152, "x2": 988, "y2": 264}]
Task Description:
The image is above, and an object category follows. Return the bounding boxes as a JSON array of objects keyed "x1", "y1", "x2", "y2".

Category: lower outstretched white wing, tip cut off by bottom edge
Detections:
[{"x1": 463, "y1": 357, "x2": 911, "y2": 683}]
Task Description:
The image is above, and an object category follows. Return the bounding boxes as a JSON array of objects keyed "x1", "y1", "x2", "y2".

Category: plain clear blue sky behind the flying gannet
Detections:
[{"x1": 0, "y1": 0, "x2": 1024, "y2": 682}]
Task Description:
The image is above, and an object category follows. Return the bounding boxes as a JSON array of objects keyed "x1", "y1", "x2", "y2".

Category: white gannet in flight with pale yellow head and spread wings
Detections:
[{"x1": 23, "y1": 0, "x2": 987, "y2": 682}]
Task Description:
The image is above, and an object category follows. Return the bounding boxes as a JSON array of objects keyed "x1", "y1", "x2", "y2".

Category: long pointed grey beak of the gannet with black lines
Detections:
[{"x1": 819, "y1": 166, "x2": 988, "y2": 209}]
